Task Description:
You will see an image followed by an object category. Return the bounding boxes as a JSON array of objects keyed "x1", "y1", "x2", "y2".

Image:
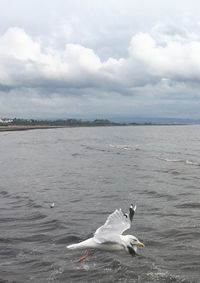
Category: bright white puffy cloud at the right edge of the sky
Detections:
[{"x1": 129, "y1": 33, "x2": 200, "y2": 80}]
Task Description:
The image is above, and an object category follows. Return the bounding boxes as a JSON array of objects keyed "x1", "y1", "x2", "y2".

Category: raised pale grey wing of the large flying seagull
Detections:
[{"x1": 94, "y1": 205, "x2": 136, "y2": 243}]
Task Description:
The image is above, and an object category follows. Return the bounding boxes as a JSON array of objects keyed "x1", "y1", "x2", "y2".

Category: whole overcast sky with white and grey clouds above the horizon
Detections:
[{"x1": 0, "y1": 0, "x2": 200, "y2": 119}]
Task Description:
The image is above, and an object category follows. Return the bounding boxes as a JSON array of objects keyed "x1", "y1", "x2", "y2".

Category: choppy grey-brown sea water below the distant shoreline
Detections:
[{"x1": 0, "y1": 125, "x2": 200, "y2": 283}]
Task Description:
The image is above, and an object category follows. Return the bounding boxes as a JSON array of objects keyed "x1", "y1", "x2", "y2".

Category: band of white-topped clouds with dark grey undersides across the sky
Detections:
[{"x1": 0, "y1": 28, "x2": 200, "y2": 89}]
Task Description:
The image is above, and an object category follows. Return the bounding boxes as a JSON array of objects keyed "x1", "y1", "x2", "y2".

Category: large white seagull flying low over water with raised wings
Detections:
[{"x1": 67, "y1": 204, "x2": 144, "y2": 261}]
